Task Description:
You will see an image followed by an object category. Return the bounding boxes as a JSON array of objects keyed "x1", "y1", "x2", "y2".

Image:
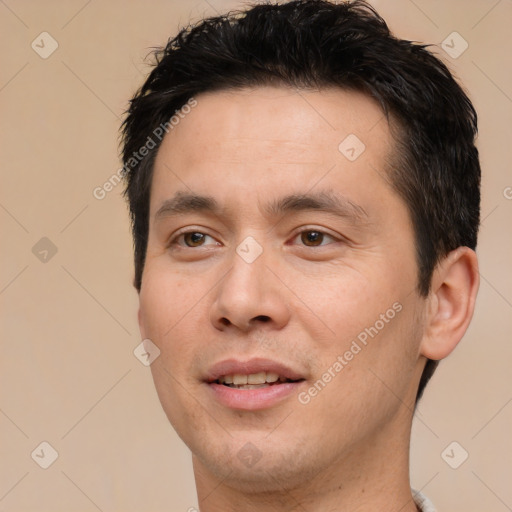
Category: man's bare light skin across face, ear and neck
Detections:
[{"x1": 139, "y1": 87, "x2": 478, "y2": 512}]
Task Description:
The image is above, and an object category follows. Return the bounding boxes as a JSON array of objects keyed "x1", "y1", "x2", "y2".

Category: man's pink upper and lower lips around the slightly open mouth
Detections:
[{"x1": 205, "y1": 359, "x2": 305, "y2": 411}]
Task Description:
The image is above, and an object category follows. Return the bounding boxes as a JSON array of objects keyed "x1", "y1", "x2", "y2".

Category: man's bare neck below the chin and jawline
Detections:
[{"x1": 193, "y1": 408, "x2": 417, "y2": 512}]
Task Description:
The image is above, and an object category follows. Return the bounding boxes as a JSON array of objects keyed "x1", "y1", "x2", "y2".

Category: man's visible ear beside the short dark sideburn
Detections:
[{"x1": 420, "y1": 247, "x2": 480, "y2": 360}]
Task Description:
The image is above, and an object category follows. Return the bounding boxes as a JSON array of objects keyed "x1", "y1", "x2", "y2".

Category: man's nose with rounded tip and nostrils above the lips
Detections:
[{"x1": 210, "y1": 248, "x2": 290, "y2": 332}]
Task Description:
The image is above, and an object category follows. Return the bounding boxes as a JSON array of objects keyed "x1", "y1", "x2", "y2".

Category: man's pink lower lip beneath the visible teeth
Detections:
[{"x1": 208, "y1": 381, "x2": 304, "y2": 411}]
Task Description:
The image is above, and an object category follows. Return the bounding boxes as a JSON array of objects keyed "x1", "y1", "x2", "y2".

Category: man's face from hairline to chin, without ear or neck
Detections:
[{"x1": 139, "y1": 87, "x2": 425, "y2": 489}]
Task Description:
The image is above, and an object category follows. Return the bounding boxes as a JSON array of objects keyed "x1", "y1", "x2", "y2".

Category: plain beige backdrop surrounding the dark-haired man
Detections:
[{"x1": 0, "y1": 0, "x2": 512, "y2": 512}]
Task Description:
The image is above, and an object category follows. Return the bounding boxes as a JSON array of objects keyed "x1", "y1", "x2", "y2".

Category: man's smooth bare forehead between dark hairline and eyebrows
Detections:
[{"x1": 151, "y1": 87, "x2": 393, "y2": 214}]
